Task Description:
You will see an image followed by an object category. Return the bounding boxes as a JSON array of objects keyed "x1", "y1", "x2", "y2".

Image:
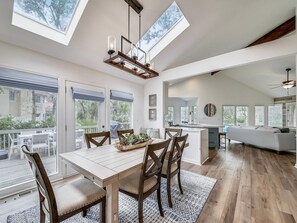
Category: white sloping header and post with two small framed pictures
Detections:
[{"x1": 144, "y1": 35, "x2": 297, "y2": 128}]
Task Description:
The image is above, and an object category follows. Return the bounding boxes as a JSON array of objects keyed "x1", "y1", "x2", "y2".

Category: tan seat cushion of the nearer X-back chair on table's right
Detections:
[{"x1": 120, "y1": 171, "x2": 158, "y2": 194}]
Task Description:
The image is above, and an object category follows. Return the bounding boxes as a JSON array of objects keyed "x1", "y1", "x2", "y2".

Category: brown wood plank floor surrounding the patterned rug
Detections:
[{"x1": 0, "y1": 142, "x2": 297, "y2": 223}]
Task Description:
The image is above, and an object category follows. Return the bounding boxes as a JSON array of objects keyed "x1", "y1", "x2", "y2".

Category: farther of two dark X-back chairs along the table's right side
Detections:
[{"x1": 161, "y1": 134, "x2": 188, "y2": 208}]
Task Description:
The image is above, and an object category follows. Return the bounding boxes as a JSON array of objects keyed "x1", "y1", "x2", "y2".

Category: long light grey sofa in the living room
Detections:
[{"x1": 226, "y1": 126, "x2": 296, "y2": 151}]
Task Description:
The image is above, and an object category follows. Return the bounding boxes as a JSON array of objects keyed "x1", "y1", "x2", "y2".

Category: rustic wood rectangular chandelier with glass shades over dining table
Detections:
[{"x1": 104, "y1": 0, "x2": 159, "y2": 79}]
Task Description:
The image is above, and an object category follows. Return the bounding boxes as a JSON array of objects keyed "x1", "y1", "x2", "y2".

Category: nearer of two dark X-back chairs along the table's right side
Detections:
[{"x1": 119, "y1": 139, "x2": 170, "y2": 223}]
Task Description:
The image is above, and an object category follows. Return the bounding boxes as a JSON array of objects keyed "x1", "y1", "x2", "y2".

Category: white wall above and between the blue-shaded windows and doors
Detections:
[{"x1": 0, "y1": 42, "x2": 144, "y2": 147}]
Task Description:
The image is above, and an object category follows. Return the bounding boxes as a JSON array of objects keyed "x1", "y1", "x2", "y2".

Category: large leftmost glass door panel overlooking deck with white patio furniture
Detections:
[{"x1": 0, "y1": 86, "x2": 58, "y2": 197}]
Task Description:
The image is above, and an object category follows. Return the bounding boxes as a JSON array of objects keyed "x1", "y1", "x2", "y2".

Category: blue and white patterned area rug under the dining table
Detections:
[{"x1": 7, "y1": 171, "x2": 216, "y2": 223}]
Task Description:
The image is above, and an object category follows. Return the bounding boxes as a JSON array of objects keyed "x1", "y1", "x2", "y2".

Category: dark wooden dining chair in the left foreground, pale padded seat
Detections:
[{"x1": 22, "y1": 145, "x2": 106, "y2": 223}]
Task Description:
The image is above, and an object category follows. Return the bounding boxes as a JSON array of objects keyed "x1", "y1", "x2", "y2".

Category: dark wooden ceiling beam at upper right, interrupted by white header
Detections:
[{"x1": 211, "y1": 16, "x2": 296, "y2": 75}]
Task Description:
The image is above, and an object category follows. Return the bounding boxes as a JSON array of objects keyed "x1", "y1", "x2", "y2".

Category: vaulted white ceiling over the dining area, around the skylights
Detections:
[{"x1": 0, "y1": 0, "x2": 296, "y2": 89}]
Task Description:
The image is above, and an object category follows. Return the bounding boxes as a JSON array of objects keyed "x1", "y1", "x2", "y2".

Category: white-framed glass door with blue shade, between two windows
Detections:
[{"x1": 65, "y1": 81, "x2": 106, "y2": 152}]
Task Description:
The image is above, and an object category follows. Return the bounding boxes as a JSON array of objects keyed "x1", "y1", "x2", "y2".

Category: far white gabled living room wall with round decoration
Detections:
[{"x1": 168, "y1": 74, "x2": 273, "y2": 125}]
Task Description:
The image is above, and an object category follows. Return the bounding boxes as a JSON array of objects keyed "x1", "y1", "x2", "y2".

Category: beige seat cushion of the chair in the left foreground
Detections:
[{"x1": 44, "y1": 178, "x2": 106, "y2": 216}]
